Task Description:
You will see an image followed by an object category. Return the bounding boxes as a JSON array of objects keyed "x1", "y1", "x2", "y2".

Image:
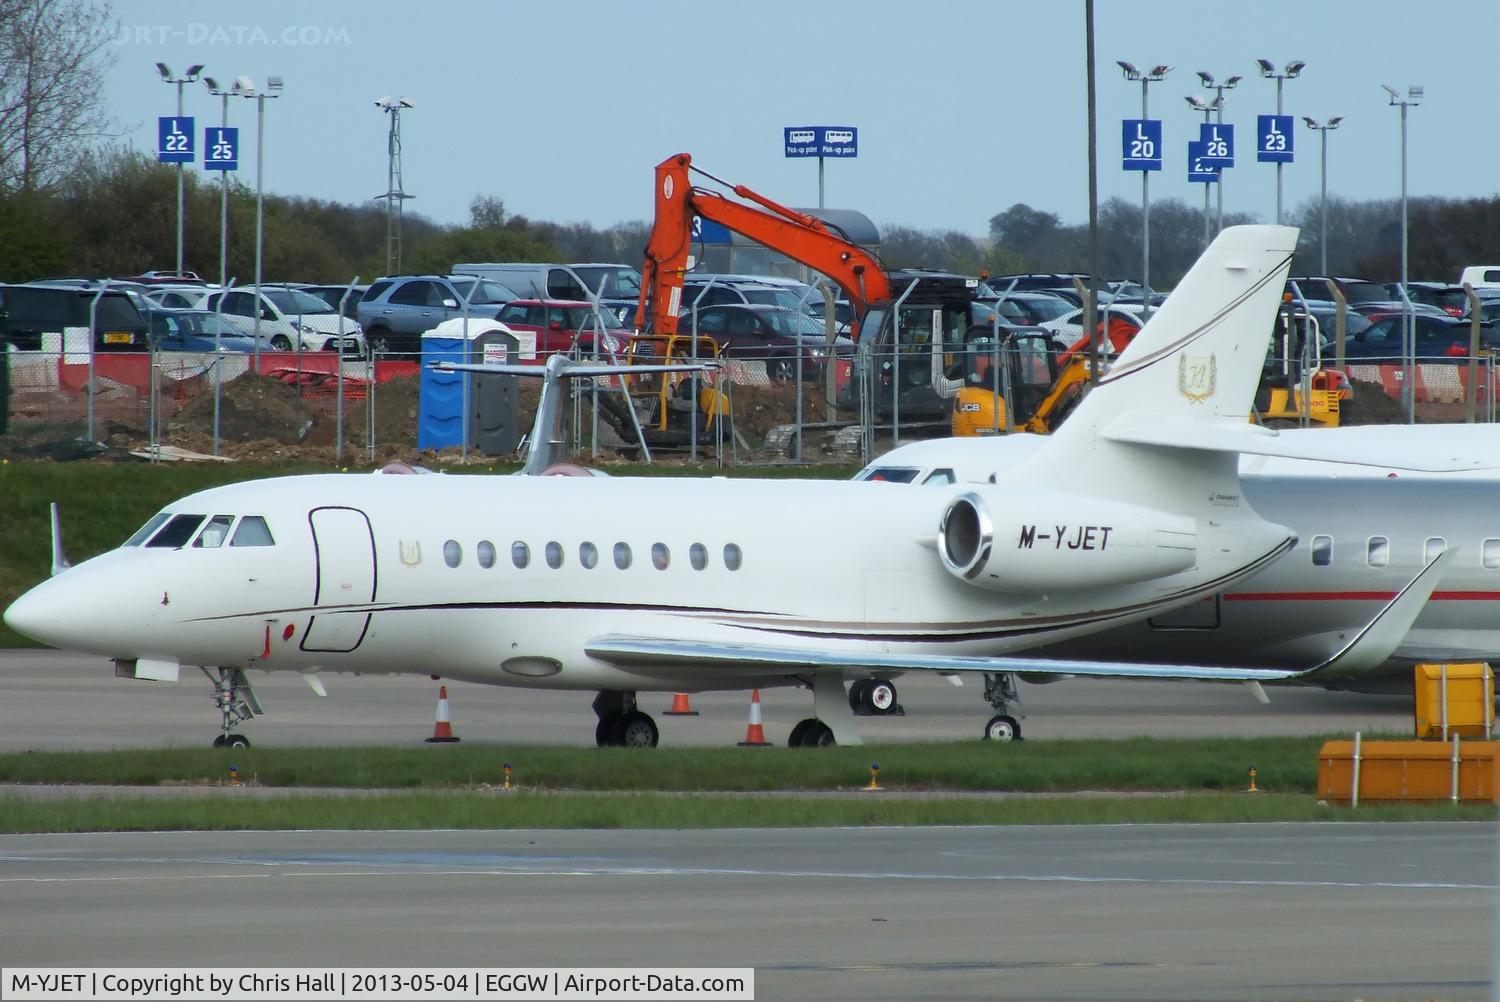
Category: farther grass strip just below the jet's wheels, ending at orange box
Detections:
[{"x1": 0, "y1": 735, "x2": 1376, "y2": 794}]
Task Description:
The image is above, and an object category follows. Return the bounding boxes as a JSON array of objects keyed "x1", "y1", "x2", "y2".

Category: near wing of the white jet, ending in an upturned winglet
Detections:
[{"x1": 585, "y1": 549, "x2": 1458, "y2": 683}]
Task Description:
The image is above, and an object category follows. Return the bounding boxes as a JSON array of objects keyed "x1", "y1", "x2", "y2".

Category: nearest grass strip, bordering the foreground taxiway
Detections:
[{"x1": 0, "y1": 792, "x2": 1496, "y2": 833}]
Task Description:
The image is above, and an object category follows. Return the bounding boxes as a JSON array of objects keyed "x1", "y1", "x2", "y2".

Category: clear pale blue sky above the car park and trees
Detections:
[{"x1": 105, "y1": 0, "x2": 1500, "y2": 236}]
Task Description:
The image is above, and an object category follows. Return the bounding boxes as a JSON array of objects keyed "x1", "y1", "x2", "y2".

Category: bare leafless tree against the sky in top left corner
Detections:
[{"x1": 0, "y1": 0, "x2": 114, "y2": 192}]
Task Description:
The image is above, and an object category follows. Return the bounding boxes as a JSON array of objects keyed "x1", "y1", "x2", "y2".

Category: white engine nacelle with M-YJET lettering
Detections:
[{"x1": 938, "y1": 491, "x2": 1199, "y2": 593}]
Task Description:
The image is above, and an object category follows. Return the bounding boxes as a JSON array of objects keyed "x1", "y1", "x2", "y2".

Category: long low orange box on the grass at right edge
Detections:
[{"x1": 1317, "y1": 735, "x2": 1500, "y2": 804}]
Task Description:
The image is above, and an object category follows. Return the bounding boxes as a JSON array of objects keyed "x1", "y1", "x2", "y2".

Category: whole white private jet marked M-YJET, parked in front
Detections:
[{"x1": 6, "y1": 227, "x2": 1470, "y2": 746}]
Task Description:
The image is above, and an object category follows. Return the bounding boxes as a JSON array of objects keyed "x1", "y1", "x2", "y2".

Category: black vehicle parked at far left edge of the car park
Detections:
[{"x1": 0, "y1": 282, "x2": 150, "y2": 351}]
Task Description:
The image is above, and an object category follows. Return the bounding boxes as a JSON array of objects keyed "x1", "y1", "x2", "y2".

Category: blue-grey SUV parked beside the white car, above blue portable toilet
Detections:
[{"x1": 359, "y1": 275, "x2": 519, "y2": 356}]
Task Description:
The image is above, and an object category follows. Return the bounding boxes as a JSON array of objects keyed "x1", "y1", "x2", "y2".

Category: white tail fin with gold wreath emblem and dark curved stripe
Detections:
[{"x1": 1014, "y1": 227, "x2": 1298, "y2": 510}]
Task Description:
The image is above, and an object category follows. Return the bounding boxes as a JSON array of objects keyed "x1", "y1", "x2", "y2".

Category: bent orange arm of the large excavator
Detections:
[{"x1": 636, "y1": 153, "x2": 891, "y2": 335}]
